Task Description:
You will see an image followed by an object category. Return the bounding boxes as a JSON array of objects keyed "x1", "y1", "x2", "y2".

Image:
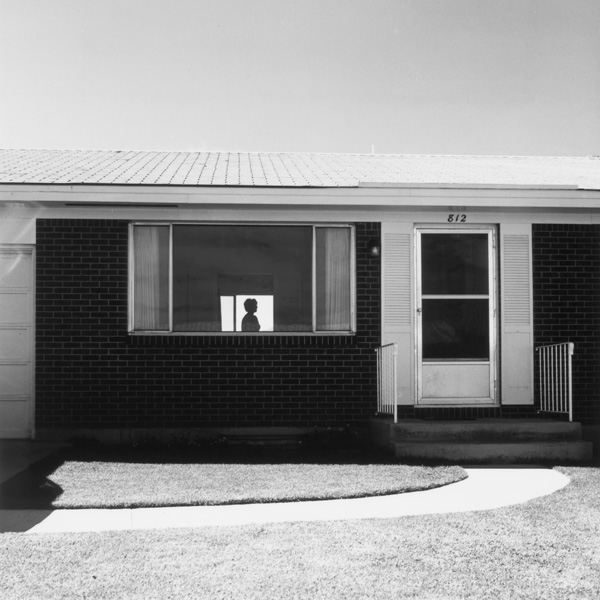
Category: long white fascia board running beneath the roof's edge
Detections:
[{"x1": 0, "y1": 184, "x2": 600, "y2": 210}]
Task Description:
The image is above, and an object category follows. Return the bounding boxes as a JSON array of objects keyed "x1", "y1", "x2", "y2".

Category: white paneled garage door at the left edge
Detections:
[{"x1": 0, "y1": 246, "x2": 33, "y2": 438}]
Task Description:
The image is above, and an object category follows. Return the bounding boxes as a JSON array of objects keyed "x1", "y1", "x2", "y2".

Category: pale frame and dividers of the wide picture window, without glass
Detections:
[{"x1": 127, "y1": 220, "x2": 356, "y2": 337}]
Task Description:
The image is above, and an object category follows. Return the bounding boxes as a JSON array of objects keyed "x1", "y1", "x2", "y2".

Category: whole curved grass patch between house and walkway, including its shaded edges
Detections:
[{"x1": 4, "y1": 450, "x2": 467, "y2": 508}]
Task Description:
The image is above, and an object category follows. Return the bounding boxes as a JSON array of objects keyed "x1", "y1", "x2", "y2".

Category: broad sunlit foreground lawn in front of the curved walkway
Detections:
[{"x1": 0, "y1": 468, "x2": 600, "y2": 600}]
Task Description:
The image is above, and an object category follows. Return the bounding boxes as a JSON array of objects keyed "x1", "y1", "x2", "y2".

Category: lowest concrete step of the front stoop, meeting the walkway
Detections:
[{"x1": 394, "y1": 440, "x2": 593, "y2": 464}]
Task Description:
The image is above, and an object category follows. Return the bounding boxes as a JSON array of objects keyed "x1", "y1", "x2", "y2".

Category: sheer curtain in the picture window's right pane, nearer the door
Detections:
[{"x1": 316, "y1": 227, "x2": 351, "y2": 331}]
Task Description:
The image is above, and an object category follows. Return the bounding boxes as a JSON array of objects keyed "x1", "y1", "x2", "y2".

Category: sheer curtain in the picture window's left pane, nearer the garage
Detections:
[{"x1": 133, "y1": 226, "x2": 169, "y2": 331}]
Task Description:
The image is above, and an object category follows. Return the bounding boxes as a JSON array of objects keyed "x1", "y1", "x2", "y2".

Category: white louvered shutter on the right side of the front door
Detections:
[{"x1": 501, "y1": 224, "x2": 534, "y2": 404}]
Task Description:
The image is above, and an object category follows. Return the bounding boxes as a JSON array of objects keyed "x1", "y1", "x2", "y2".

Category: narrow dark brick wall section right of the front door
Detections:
[{"x1": 533, "y1": 225, "x2": 600, "y2": 423}]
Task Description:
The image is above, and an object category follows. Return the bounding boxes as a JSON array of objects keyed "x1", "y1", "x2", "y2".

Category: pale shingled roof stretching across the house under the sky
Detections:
[{"x1": 0, "y1": 150, "x2": 600, "y2": 190}]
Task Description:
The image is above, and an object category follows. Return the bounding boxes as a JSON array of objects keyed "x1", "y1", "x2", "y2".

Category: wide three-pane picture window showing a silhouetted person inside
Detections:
[{"x1": 130, "y1": 223, "x2": 354, "y2": 334}]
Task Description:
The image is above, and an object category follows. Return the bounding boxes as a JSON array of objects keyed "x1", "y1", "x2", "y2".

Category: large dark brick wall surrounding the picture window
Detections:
[{"x1": 36, "y1": 219, "x2": 380, "y2": 429}]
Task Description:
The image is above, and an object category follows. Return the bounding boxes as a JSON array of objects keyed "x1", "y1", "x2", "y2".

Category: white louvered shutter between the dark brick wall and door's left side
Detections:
[{"x1": 381, "y1": 223, "x2": 414, "y2": 404}]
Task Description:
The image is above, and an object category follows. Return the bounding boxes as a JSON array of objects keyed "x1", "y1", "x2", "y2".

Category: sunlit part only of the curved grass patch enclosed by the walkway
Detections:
[{"x1": 50, "y1": 461, "x2": 466, "y2": 508}]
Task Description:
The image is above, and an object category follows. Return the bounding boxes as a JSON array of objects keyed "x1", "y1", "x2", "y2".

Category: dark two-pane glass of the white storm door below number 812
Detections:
[{"x1": 421, "y1": 233, "x2": 490, "y2": 361}]
